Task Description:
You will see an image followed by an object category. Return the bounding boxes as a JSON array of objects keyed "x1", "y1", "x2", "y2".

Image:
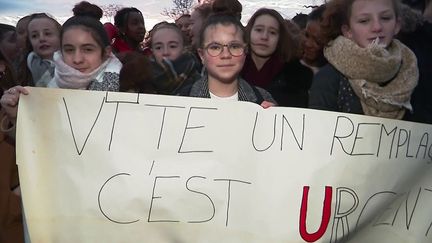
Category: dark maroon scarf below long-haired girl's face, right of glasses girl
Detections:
[{"x1": 241, "y1": 54, "x2": 285, "y2": 89}]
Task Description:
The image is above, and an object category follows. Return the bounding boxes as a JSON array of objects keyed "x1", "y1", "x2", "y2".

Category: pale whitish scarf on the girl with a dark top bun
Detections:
[{"x1": 51, "y1": 51, "x2": 122, "y2": 89}]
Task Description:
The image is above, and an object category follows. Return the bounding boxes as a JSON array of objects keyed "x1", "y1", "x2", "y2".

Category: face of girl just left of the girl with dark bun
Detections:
[{"x1": 28, "y1": 18, "x2": 60, "y2": 59}]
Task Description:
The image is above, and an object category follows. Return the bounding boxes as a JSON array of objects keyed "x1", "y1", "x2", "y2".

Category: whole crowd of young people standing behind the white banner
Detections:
[{"x1": 0, "y1": 0, "x2": 432, "y2": 242}]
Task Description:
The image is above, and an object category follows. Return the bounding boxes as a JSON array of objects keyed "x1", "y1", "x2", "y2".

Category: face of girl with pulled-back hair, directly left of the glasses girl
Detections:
[{"x1": 152, "y1": 28, "x2": 183, "y2": 63}]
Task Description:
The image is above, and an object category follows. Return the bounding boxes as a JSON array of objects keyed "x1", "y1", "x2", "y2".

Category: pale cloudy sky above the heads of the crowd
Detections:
[{"x1": 0, "y1": 0, "x2": 323, "y2": 28}]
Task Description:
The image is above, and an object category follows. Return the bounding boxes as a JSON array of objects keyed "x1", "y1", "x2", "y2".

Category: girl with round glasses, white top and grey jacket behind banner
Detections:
[{"x1": 180, "y1": 14, "x2": 276, "y2": 108}]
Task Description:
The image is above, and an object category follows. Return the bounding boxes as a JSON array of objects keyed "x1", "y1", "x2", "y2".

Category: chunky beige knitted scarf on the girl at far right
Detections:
[{"x1": 324, "y1": 36, "x2": 419, "y2": 119}]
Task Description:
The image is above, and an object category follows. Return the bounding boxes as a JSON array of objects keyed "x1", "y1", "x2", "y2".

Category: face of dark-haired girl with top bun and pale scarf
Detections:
[{"x1": 62, "y1": 26, "x2": 110, "y2": 73}]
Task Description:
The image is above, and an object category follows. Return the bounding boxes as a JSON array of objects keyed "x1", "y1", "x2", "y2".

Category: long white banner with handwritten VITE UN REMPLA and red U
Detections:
[{"x1": 17, "y1": 88, "x2": 432, "y2": 243}]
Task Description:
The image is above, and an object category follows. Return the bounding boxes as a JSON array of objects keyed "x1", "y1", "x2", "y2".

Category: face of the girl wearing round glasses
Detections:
[{"x1": 198, "y1": 24, "x2": 246, "y2": 83}]
